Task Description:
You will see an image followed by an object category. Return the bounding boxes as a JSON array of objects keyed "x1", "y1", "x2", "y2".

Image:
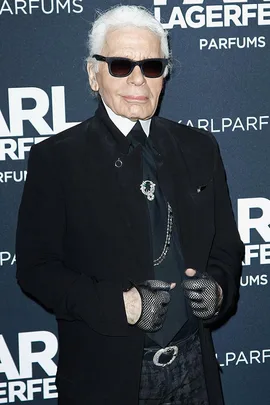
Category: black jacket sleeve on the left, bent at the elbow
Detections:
[{"x1": 16, "y1": 141, "x2": 130, "y2": 336}]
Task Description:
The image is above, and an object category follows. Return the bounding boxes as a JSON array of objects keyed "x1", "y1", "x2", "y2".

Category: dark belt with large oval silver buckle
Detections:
[{"x1": 143, "y1": 330, "x2": 198, "y2": 367}]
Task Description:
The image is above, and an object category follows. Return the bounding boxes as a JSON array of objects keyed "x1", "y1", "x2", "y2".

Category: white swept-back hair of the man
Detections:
[{"x1": 87, "y1": 5, "x2": 171, "y2": 77}]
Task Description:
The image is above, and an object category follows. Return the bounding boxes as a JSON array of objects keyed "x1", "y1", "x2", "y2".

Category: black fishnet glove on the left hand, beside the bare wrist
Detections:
[{"x1": 135, "y1": 280, "x2": 171, "y2": 332}]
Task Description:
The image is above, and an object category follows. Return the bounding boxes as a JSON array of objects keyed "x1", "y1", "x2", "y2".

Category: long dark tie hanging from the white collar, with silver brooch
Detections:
[{"x1": 128, "y1": 121, "x2": 187, "y2": 347}]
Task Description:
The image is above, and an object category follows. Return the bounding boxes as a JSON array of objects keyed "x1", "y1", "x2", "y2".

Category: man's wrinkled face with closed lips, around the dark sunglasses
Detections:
[{"x1": 87, "y1": 27, "x2": 164, "y2": 120}]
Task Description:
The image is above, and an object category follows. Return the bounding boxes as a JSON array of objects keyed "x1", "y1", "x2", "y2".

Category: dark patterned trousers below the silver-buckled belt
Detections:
[{"x1": 139, "y1": 332, "x2": 208, "y2": 405}]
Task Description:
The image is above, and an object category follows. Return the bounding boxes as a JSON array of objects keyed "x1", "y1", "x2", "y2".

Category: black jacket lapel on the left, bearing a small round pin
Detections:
[{"x1": 84, "y1": 106, "x2": 154, "y2": 281}]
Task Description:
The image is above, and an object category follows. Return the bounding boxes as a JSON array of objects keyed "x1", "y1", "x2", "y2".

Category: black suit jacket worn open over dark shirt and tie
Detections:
[{"x1": 16, "y1": 108, "x2": 243, "y2": 405}]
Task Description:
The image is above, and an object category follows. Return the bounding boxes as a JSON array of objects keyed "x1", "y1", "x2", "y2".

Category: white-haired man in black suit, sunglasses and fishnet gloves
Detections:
[{"x1": 17, "y1": 6, "x2": 243, "y2": 405}]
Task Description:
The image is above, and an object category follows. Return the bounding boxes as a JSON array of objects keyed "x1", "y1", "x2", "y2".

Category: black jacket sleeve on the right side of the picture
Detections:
[{"x1": 204, "y1": 137, "x2": 244, "y2": 326}]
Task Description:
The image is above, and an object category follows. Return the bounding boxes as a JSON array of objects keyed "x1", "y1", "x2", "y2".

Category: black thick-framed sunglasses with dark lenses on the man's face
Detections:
[{"x1": 93, "y1": 55, "x2": 168, "y2": 79}]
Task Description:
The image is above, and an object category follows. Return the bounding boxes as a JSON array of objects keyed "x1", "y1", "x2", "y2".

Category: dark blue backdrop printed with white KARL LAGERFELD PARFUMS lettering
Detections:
[{"x1": 0, "y1": 0, "x2": 270, "y2": 405}]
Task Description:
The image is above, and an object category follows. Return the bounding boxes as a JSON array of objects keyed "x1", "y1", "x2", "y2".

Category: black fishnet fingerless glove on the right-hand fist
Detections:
[{"x1": 182, "y1": 271, "x2": 222, "y2": 319}]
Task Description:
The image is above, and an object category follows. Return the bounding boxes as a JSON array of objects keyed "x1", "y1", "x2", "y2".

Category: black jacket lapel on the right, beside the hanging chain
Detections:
[{"x1": 150, "y1": 119, "x2": 207, "y2": 268}]
